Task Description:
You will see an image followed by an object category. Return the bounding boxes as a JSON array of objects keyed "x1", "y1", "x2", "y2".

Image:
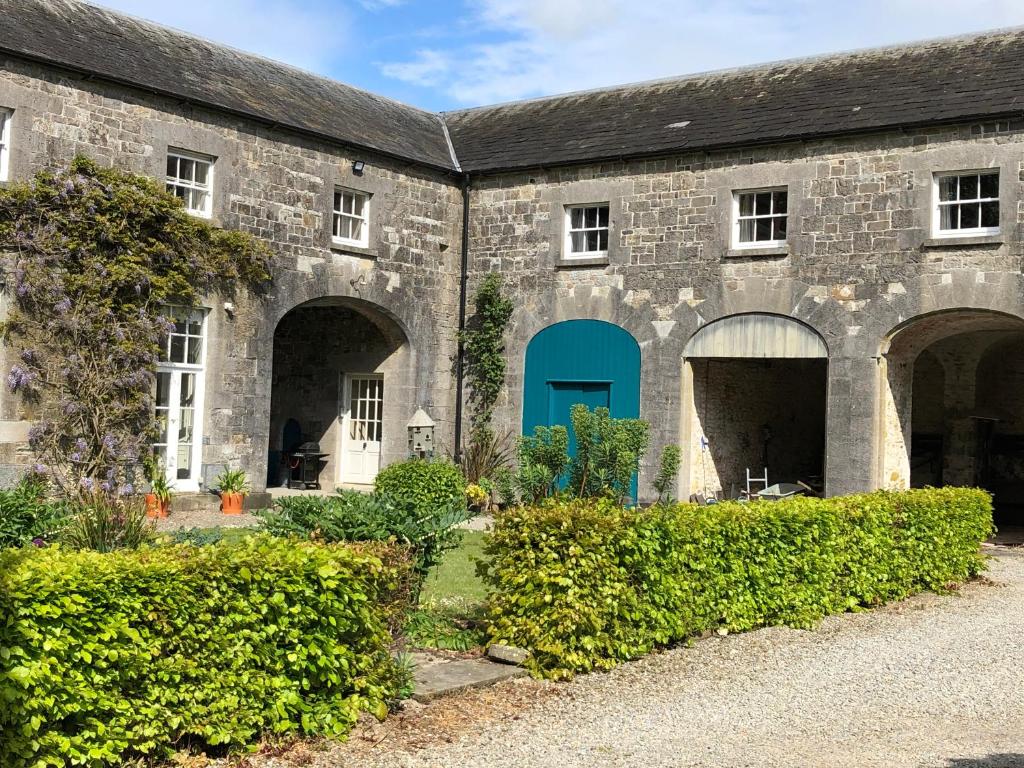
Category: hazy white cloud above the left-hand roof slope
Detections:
[{"x1": 96, "y1": 0, "x2": 348, "y2": 72}]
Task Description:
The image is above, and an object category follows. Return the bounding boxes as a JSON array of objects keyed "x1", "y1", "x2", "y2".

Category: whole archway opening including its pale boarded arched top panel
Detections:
[{"x1": 680, "y1": 312, "x2": 828, "y2": 499}]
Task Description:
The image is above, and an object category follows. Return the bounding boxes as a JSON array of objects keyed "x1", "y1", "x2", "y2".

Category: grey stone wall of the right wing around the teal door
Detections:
[{"x1": 470, "y1": 123, "x2": 1024, "y2": 498}]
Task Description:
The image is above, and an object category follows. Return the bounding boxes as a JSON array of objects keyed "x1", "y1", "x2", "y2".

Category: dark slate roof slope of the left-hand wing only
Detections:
[{"x1": 0, "y1": 0, "x2": 454, "y2": 169}]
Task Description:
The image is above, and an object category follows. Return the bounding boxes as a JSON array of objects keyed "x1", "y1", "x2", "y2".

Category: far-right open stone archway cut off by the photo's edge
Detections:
[{"x1": 880, "y1": 308, "x2": 1024, "y2": 524}]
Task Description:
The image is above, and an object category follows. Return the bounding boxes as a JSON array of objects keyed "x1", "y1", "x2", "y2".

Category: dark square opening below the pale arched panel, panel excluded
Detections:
[{"x1": 689, "y1": 358, "x2": 828, "y2": 499}]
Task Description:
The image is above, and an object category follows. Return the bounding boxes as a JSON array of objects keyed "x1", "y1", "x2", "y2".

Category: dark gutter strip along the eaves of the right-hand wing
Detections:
[{"x1": 465, "y1": 108, "x2": 1024, "y2": 176}]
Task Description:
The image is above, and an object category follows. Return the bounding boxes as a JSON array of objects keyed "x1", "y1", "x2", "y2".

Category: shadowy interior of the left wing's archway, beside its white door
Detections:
[{"x1": 267, "y1": 300, "x2": 404, "y2": 487}]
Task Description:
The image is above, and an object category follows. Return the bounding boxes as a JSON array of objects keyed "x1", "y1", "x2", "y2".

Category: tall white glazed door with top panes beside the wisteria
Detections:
[{"x1": 153, "y1": 307, "x2": 206, "y2": 490}]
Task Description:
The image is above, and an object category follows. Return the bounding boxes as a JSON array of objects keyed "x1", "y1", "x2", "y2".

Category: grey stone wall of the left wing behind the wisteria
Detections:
[{"x1": 0, "y1": 59, "x2": 462, "y2": 487}]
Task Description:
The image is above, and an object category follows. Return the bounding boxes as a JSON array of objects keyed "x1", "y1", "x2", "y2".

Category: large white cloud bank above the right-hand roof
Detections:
[{"x1": 380, "y1": 0, "x2": 1024, "y2": 104}]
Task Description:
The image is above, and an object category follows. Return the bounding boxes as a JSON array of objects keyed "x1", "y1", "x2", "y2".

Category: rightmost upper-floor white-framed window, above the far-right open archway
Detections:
[{"x1": 934, "y1": 171, "x2": 999, "y2": 237}]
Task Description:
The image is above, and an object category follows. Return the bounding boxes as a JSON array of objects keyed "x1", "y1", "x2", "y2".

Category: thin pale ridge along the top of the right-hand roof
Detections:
[{"x1": 441, "y1": 25, "x2": 1024, "y2": 116}]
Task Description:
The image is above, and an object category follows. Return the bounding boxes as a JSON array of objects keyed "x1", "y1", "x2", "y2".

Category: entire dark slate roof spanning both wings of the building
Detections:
[{"x1": 0, "y1": 0, "x2": 1024, "y2": 172}]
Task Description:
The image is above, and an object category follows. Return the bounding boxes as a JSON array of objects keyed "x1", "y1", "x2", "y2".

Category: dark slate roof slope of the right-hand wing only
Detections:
[{"x1": 445, "y1": 29, "x2": 1024, "y2": 171}]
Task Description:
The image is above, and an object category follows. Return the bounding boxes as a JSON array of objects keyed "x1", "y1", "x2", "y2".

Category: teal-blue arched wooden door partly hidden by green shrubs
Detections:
[{"x1": 522, "y1": 319, "x2": 640, "y2": 498}]
